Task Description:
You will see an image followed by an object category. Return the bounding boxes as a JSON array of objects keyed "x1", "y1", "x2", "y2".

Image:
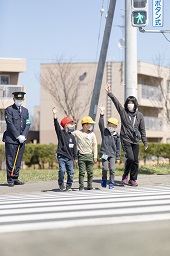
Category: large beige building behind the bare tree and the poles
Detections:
[{"x1": 40, "y1": 62, "x2": 170, "y2": 144}]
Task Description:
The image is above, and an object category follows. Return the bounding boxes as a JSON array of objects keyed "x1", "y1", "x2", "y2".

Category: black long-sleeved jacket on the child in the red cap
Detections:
[{"x1": 54, "y1": 118, "x2": 77, "y2": 160}]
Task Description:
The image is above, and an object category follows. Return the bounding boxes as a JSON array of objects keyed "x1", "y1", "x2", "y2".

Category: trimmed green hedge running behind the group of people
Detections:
[{"x1": 0, "y1": 143, "x2": 170, "y2": 169}]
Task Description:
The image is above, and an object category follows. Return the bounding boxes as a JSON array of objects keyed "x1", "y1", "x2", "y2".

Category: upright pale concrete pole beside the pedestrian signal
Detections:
[{"x1": 125, "y1": 0, "x2": 137, "y2": 99}]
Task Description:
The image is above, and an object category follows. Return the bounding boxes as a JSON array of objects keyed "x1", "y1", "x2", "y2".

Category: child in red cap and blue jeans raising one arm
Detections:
[{"x1": 52, "y1": 107, "x2": 77, "y2": 191}]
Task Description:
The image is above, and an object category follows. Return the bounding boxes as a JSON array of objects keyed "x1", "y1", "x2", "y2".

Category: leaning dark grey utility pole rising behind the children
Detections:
[{"x1": 89, "y1": 0, "x2": 116, "y2": 120}]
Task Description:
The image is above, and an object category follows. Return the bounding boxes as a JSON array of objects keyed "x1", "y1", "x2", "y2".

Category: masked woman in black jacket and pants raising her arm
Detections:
[{"x1": 105, "y1": 84, "x2": 148, "y2": 186}]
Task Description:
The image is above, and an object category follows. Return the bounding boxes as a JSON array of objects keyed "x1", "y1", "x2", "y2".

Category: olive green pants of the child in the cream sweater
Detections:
[{"x1": 78, "y1": 154, "x2": 94, "y2": 188}]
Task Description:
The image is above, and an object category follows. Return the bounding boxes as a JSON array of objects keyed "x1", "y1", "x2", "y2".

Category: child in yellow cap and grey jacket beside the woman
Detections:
[{"x1": 99, "y1": 106, "x2": 120, "y2": 189}]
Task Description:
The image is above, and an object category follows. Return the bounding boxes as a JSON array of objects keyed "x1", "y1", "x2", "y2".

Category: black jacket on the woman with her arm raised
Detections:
[{"x1": 108, "y1": 92, "x2": 147, "y2": 146}]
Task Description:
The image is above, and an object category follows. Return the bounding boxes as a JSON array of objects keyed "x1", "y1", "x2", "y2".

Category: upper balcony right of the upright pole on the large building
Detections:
[{"x1": 138, "y1": 84, "x2": 163, "y2": 108}]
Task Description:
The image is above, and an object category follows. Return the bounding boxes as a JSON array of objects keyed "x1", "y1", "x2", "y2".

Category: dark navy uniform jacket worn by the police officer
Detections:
[{"x1": 3, "y1": 104, "x2": 30, "y2": 144}]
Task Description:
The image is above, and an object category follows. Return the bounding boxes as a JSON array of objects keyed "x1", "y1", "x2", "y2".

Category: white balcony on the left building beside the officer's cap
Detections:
[{"x1": 0, "y1": 85, "x2": 24, "y2": 109}]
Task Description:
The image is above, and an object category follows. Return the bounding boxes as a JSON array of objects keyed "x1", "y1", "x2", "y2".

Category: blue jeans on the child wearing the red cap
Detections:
[{"x1": 57, "y1": 154, "x2": 74, "y2": 186}]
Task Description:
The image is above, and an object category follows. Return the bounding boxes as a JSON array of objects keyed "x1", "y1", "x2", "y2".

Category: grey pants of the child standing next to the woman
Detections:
[{"x1": 102, "y1": 157, "x2": 115, "y2": 184}]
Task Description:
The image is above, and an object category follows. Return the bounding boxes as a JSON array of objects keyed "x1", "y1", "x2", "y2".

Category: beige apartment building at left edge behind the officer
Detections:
[{"x1": 0, "y1": 59, "x2": 26, "y2": 144}]
